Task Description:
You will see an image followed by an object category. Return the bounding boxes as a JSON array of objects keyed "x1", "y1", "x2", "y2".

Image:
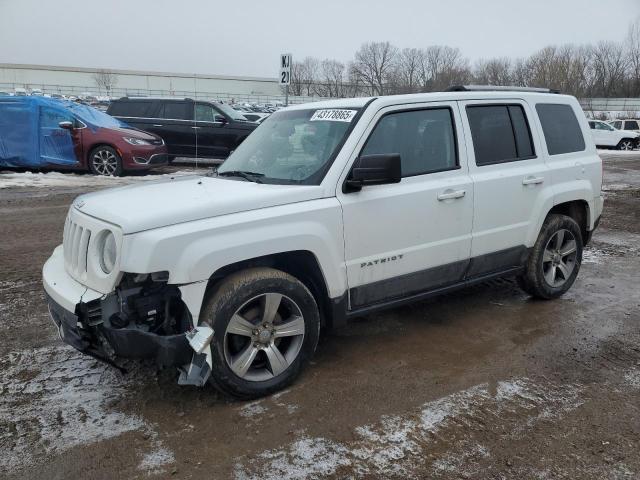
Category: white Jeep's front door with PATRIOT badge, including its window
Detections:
[{"x1": 337, "y1": 102, "x2": 474, "y2": 309}]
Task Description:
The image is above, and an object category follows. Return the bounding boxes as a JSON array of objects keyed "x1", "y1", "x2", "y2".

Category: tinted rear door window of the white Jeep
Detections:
[{"x1": 467, "y1": 105, "x2": 535, "y2": 166}]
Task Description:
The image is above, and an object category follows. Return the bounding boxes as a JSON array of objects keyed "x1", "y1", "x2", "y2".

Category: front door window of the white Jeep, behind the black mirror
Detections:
[{"x1": 360, "y1": 108, "x2": 458, "y2": 177}]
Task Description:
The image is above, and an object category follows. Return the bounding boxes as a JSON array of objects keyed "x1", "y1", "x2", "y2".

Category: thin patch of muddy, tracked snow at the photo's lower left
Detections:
[{"x1": 0, "y1": 346, "x2": 147, "y2": 472}]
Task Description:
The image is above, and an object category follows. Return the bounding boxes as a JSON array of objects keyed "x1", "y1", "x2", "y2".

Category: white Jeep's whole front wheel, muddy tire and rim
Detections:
[{"x1": 202, "y1": 268, "x2": 320, "y2": 399}]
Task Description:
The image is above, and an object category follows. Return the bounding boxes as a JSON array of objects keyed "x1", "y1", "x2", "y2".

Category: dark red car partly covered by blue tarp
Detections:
[{"x1": 0, "y1": 97, "x2": 168, "y2": 175}]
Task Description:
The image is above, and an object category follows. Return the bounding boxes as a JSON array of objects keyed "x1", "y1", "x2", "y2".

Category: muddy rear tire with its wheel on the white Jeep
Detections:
[{"x1": 518, "y1": 214, "x2": 583, "y2": 300}]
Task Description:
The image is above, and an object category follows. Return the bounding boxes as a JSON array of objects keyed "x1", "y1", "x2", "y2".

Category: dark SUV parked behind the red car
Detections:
[{"x1": 107, "y1": 97, "x2": 258, "y2": 159}]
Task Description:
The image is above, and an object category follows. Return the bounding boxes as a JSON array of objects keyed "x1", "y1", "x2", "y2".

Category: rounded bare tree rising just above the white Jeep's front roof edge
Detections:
[{"x1": 352, "y1": 42, "x2": 398, "y2": 95}]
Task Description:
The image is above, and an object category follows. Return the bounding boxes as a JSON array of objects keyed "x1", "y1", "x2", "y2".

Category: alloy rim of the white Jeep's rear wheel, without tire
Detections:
[{"x1": 542, "y1": 229, "x2": 578, "y2": 288}]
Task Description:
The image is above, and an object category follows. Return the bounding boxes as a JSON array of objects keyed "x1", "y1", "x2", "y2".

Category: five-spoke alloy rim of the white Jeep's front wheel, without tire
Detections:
[{"x1": 224, "y1": 293, "x2": 305, "y2": 382}]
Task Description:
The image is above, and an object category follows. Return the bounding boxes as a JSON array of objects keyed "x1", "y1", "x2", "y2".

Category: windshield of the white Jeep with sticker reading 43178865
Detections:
[{"x1": 218, "y1": 108, "x2": 359, "y2": 185}]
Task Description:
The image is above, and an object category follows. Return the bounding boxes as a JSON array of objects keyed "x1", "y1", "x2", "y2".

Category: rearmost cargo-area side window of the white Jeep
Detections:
[{"x1": 536, "y1": 103, "x2": 585, "y2": 155}]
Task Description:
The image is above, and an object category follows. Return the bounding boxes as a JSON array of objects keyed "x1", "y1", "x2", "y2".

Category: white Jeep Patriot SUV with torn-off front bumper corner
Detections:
[{"x1": 43, "y1": 87, "x2": 603, "y2": 398}]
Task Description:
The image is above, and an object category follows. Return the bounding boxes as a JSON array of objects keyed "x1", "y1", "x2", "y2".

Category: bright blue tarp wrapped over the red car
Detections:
[{"x1": 0, "y1": 96, "x2": 126, "y2": 168}]
